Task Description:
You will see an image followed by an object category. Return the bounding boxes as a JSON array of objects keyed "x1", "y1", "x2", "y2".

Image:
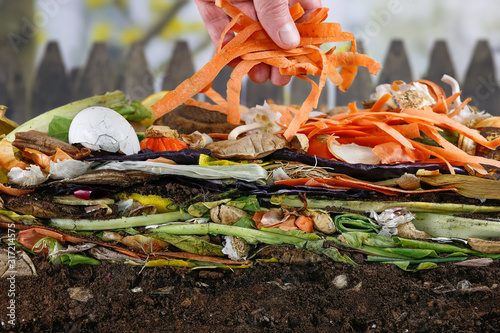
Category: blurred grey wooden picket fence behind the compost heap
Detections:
[{"x1": 0, "y1": 40, "x2": 500, "y2": 123}]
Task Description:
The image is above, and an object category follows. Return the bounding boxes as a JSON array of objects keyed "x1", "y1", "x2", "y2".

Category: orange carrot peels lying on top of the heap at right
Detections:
[{"x1": 298, "y1": 80, "x2": 500, "y2": 175}]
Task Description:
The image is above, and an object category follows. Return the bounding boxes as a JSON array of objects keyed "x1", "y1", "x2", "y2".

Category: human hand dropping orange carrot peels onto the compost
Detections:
[{"x1": 195, "y1": 0, "x2": 321, "y2": 86}]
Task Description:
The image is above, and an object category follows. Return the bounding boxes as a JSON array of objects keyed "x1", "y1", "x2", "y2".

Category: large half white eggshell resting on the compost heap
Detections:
[{"x1": 68, "y1": 106, "x2": 140, "y2": 155}]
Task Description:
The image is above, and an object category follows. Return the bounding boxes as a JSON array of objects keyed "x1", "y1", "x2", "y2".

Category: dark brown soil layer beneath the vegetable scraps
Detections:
[{"x1": 0, "y1": 248, "x2": 500, "y2": 332}]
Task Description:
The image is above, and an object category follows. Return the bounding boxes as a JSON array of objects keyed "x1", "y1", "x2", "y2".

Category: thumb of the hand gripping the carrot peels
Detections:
[{"x1": 254, "y1": 0, "x2": 300, "y2": 49}]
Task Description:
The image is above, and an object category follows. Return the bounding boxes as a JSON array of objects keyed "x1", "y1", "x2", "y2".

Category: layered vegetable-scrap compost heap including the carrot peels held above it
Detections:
[{"x1": 0, "y1": 1, "x2": 500, "y2": 270}]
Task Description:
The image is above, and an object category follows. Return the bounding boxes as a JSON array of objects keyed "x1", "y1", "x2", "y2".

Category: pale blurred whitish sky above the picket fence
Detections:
[{"x1": 38, "y1": 0, "x2": 500, "y2": 85}]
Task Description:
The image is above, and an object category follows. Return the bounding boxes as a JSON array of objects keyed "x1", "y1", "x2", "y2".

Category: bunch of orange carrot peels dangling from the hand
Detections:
[{"x1": 153, "y1": 0, "x2": 381, "y2": 140}]
